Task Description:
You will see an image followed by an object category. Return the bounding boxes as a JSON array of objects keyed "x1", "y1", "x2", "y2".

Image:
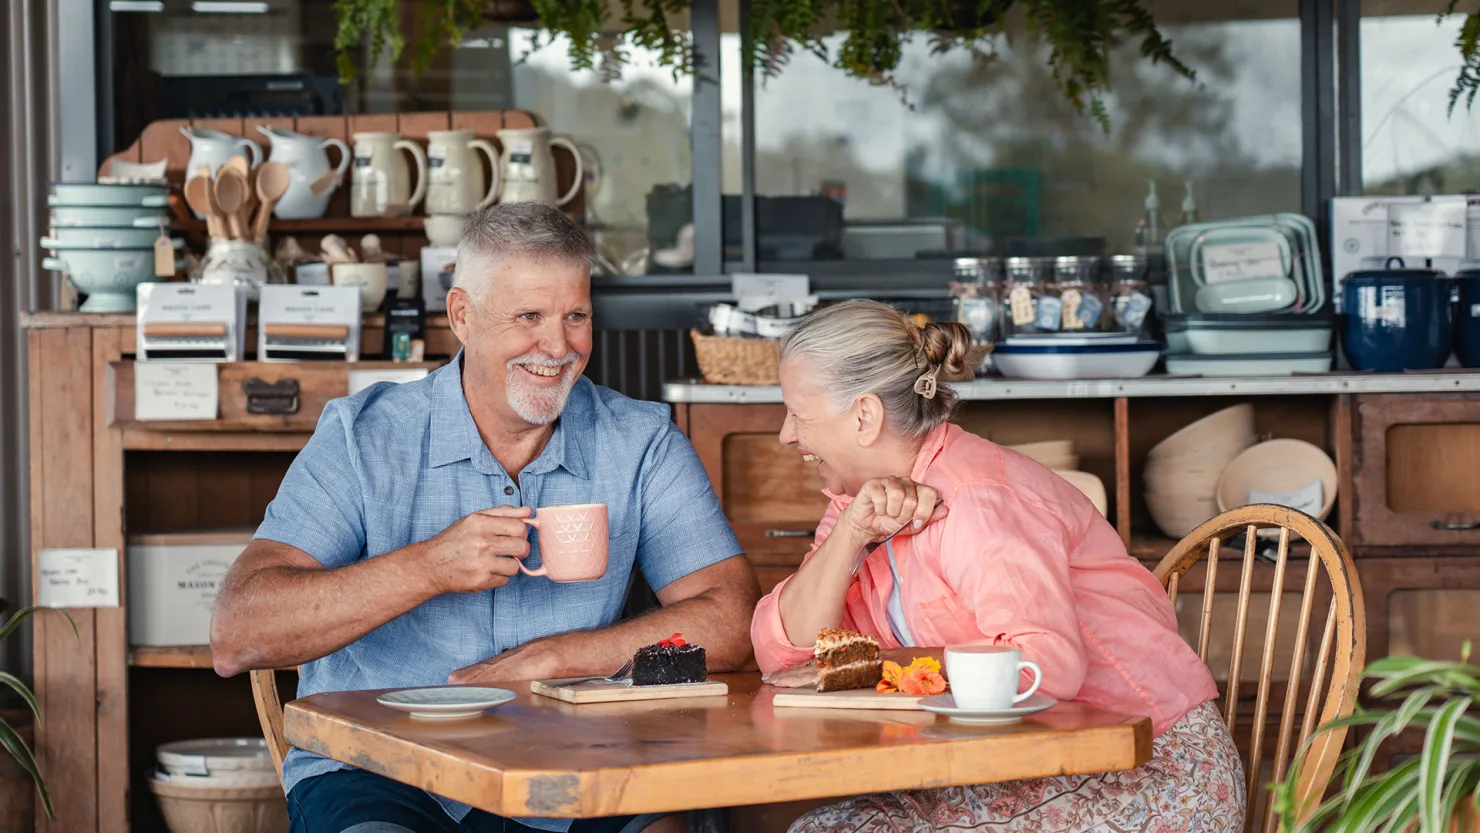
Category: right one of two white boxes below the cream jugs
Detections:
[{"x1": 258, "y1": 284, "x2": 360, "y2": 361}]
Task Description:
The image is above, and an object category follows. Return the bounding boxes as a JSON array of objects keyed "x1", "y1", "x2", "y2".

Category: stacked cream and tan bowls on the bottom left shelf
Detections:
[{"x1": 149, "y1": 738, "x2": 289, "y2": 833}]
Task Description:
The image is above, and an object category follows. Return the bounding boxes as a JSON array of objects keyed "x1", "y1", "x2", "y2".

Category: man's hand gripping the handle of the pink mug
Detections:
[{"x1": 419, "y1": 506, "x2": 530, "y2": 593}]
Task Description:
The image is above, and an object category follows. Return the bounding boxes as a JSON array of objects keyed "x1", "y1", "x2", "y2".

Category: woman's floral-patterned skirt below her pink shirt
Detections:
[{"x1": 790, "y1": 703, "x2": 1245, "y2": 833}]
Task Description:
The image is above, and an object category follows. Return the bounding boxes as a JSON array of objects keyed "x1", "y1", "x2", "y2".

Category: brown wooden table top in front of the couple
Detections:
[{"x1": 284, "y1": 673, "x2": 1151, "y2": 818}]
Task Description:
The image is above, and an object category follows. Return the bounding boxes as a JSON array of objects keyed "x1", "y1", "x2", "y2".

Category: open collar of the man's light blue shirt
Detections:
[{"x1": 428, "y1": 349, "x2": 592, "y2": 479}]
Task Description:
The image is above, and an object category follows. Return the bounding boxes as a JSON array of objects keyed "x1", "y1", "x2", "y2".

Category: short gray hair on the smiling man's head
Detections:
[{"x1": 453, "y1": 203, "x2": 596, "y2": 297}]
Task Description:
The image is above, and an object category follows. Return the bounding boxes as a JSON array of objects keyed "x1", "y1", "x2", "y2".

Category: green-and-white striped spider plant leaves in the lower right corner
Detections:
[{"x1": 1274, "y1": 642, "x2": 1480, "y2": 833}]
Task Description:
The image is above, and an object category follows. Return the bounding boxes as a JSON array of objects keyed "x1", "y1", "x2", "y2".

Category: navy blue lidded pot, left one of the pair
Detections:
[{"x1": 1341, "y1": 269, "x2": 1453, "y2": 373}]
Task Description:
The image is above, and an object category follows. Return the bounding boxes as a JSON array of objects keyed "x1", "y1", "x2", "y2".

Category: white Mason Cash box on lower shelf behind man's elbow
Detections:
[{"x1": 126, "y1": 530, "x2": 252, "y2": 647}]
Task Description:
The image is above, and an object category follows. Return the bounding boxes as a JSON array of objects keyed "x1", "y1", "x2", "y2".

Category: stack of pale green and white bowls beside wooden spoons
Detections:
[{"x1": 41, "y1": 182, "x2": 184, "y2": 312}]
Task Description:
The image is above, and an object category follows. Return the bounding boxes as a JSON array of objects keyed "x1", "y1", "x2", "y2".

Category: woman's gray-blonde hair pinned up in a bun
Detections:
[{"x1": 781, "y1": 300, "x2": 971, "y2": 438}]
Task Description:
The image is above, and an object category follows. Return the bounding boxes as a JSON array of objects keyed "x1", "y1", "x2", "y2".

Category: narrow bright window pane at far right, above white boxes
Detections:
[{"x1": 1362, "y1": 0, "x2": 1480, "y2": 194}]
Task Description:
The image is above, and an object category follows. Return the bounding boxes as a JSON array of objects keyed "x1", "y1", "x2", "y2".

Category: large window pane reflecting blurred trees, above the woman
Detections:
[{"x1": 727, "y1": 0, "x2": 1301, "y2": 259}]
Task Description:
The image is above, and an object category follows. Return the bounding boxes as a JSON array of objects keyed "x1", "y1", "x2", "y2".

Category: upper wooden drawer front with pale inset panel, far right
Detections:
[{"x1": 1350, "y1": 394, "x2": 1480, "y2": 547}]
